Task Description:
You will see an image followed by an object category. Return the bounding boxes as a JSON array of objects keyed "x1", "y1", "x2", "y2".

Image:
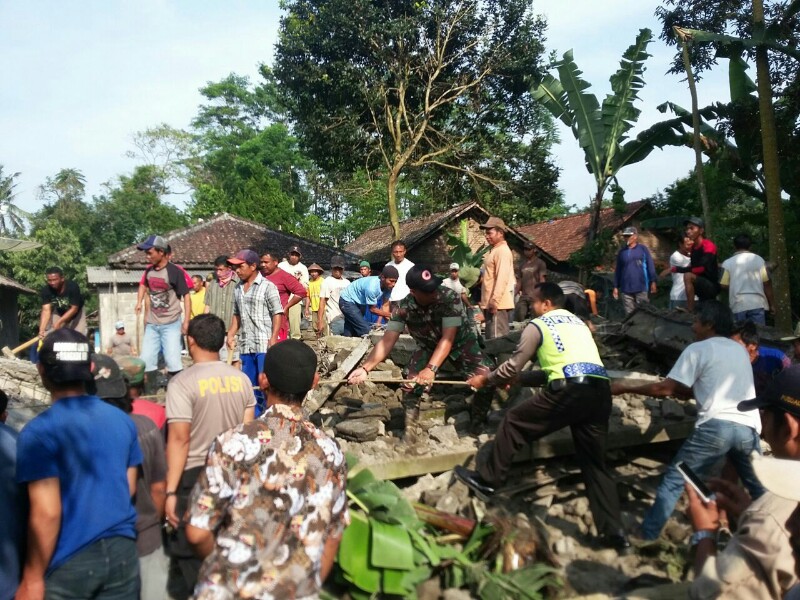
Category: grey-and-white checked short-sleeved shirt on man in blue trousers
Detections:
[{"x1": 233, "y1": 273, "x2": 283, "y2": 354}]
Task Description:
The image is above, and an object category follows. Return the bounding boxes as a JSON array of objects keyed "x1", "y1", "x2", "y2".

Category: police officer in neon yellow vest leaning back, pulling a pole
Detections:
[{"x1": 454, "y1": 282, "x2": 630, "y2": 552}]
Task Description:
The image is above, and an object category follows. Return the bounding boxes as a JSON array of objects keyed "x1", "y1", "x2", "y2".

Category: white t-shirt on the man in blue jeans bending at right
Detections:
[{"x1": 667, "y1": 336, "x2": 761, "y2": 432}]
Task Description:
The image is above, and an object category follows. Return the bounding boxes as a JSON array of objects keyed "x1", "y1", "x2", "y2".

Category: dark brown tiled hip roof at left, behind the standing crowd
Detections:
[{"x1": 108, "y1": 213, "x2": 360, "y2": 269}]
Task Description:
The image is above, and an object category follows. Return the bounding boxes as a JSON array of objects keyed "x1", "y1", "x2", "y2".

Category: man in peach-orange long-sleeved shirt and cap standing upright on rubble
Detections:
[{"x1": 480, "y1": 217, "x2": 517, "y2": 340}]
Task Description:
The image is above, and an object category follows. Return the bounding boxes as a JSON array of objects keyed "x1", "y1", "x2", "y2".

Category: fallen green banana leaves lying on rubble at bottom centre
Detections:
[{"x1": 336, "y1": 469, "x2": 559, "y2": 600}]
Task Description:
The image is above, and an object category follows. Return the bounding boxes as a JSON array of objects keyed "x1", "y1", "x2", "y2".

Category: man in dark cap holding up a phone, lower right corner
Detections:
[{"x1": 686, "y1": 366, "x2": 800, "y2": 599}]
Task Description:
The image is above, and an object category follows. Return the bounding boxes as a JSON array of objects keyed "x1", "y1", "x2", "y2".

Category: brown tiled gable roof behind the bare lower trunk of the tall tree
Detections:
[{"x1": 345, "y1": 201, "x2": 536, "y2": 263}]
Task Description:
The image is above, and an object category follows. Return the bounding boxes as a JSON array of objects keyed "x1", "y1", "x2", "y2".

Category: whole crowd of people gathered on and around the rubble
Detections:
[{"x1": 0, "y1": 217, "x2": 800, "y2": 600}]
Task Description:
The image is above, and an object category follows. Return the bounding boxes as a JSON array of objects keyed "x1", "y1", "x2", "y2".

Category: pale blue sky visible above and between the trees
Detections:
[{"x1": 0, "y1": 0, "x2": 728, "y2": 216}]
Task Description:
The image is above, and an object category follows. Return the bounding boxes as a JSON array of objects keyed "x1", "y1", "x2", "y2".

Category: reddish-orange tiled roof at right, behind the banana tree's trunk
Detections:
[{"x1": 517, "y1": 200, "x2": 648, "y2": 262}]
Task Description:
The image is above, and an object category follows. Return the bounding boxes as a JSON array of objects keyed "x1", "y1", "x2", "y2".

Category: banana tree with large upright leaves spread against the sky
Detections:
[{"x1": 532, "y1": 29, "x2": 684, "y2": 242}]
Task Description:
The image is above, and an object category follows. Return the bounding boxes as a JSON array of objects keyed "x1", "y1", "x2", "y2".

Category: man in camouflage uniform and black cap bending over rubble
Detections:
[{"x1": 348, "y1": 265, "x2": 494, "y2": 433}]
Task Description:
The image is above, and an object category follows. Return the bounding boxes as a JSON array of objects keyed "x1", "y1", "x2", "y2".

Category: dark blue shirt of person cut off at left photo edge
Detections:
[{"x1": 0, "y1": 423, "x2": 28, "y2": 600}]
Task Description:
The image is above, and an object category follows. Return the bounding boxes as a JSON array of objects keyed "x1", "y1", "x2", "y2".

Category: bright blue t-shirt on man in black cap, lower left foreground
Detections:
[{"x1": 17, "y1": 396, "x2": 142, "y2": 574}]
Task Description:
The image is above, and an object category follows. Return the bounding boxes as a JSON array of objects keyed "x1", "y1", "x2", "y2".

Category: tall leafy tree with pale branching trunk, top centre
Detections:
[{"x1": 275, "y1": 0, "x2": 546, "y2": 236}]
